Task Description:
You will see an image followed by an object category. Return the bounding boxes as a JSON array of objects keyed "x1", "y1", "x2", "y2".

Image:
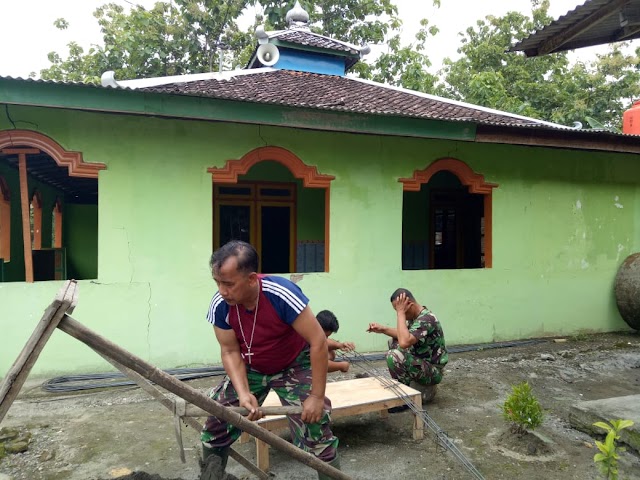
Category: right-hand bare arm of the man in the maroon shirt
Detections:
[{"x1": 291, "y1": 305, "x2": 329, "y2": 423}]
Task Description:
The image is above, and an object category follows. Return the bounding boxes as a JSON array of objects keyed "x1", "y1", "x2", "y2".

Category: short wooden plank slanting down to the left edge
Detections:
[{"x1": 0, "y1": 280, "x2": 78, "y2": 423}]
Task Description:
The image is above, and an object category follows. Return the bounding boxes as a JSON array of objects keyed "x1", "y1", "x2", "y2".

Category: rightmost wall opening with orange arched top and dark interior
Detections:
[{"x1": 399, "y1": 158, "x2": 497, "y2": 270}]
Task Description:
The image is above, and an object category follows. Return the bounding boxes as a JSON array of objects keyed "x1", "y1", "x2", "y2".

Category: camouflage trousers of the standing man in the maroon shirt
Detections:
[{"x1": 200, "y1": 348, "x2": 338, "y2": 462}]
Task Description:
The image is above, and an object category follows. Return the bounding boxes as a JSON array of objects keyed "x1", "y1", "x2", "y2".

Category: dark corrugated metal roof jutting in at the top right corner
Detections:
[{"x1": 509, "y1": 0, "x2": 640, "y2": 57}]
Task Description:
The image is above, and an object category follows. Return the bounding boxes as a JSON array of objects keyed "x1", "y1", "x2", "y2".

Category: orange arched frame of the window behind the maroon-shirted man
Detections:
[{"x1": 207, "y1": 146, "x2": 335, "y2": 273}]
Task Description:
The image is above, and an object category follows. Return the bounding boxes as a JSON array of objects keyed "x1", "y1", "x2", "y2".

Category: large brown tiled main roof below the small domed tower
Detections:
[{"x1": 140, "y1": 70, "x2": 559, "y2": 127}]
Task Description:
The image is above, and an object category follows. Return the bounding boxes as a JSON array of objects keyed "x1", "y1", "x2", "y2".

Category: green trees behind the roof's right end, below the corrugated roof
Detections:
[{"x1": 438, "y1": 0, "x2": 640, "y2": 127}]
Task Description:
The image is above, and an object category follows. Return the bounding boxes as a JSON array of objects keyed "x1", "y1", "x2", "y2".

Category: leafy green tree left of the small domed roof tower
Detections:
[{"x1": 40, "y1": 0, "x2": 248, "y2": 83}]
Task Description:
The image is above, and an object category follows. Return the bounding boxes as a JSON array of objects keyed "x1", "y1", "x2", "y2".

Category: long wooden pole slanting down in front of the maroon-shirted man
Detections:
[{"x1": 58, "y1": 315, "x2": 351, "y2": 480}]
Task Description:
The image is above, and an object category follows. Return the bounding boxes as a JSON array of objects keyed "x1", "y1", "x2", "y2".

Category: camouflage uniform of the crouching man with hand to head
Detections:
[{"x1": 387, "y1": 308, "x2": 449, "y2": 385}]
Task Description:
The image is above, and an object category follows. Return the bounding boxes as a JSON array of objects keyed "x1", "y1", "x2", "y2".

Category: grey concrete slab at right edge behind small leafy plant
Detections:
[{"x1": 569, "y1": 395, "x2": 640, "y2": 453}]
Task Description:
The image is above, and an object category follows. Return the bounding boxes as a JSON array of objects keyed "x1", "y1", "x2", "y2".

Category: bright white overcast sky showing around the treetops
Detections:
[{"x1": 0, "y1": 0, "x2": 602, "y2": 78}]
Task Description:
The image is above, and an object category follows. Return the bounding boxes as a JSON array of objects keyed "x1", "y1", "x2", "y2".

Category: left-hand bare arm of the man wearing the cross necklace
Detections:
[{"x1": 213, "y1": 326, "x2": 264, "y2": 420}]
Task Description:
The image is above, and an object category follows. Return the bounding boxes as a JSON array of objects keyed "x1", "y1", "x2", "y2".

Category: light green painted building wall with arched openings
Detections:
[{"x1": 0, "y1": 107, "x2": 640, "y2": 375}]
